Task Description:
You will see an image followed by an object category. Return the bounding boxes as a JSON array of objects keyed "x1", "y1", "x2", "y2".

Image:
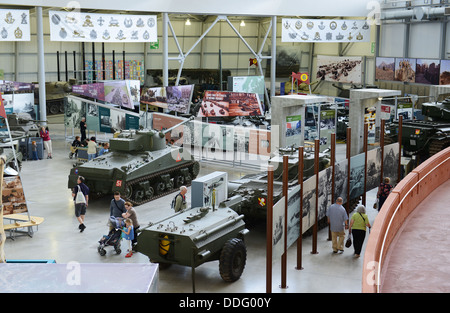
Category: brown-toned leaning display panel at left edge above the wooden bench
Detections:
[{"x1": 2, "y1": 175, "x2": 28, "y2": 215}]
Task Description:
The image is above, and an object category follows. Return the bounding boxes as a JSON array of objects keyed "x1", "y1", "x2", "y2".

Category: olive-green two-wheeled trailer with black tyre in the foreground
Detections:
[{"x1": 135, "y1": 202, "x2": 248, "y2": 288}]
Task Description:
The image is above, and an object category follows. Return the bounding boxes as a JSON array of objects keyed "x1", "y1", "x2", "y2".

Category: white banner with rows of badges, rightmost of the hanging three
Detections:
[{"x1": 281, "y1": 18, "x2": 370, "y2": 43}]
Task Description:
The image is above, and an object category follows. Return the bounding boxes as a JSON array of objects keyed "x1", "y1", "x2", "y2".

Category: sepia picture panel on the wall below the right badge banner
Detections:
[{"x1": 316, "y1": 55, "x2": 362, "y2": 84}]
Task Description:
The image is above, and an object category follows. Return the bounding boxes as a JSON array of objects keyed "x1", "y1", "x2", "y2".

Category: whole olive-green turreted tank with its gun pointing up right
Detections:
[{"x1": 68, "y1": 119, "x2": 200, "y2": 205}]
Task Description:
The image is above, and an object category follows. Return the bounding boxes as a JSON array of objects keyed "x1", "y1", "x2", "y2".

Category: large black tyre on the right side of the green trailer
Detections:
[{"x1": 219, "y1": 238, "x2": 247, "y2": 282}]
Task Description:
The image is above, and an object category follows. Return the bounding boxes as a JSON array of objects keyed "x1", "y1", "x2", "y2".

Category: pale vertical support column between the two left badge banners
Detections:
[{"x1": 36, "y1": 7, "x2": 47, "y2": 125}]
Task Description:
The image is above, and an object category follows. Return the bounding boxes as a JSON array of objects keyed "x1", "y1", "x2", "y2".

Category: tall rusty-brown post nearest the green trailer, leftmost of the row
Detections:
[{"x1": 266, "y1": 165, "x2": 273, "y2": 293}]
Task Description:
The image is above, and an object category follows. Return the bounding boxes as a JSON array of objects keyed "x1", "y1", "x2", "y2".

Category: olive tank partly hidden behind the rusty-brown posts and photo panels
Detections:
[{"x1": 225, "y1": 147, "x2": 330, "y2": 220}]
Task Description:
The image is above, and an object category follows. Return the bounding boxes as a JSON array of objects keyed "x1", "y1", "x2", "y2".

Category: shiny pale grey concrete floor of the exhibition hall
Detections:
[{"x1": 5, "y1": 118, "x2": 377, "y2": 293}]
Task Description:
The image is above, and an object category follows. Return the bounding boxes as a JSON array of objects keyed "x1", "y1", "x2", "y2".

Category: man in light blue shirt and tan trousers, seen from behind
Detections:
[{"x1": 327, "y1": 197, "x2": 348, "y2": 253}]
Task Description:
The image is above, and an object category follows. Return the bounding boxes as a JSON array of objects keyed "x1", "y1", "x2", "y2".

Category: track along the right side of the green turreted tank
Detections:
[{"x1": 122, "y1": 161, "x2": 200, "y2": 205}]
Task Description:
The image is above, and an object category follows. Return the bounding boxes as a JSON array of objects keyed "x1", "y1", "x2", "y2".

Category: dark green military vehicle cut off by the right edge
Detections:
[{"x1": 385, "y1": 98, "x2": 450, "y2": 161}]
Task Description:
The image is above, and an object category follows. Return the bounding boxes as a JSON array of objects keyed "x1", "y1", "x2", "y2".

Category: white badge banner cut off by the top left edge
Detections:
[{"x1": 0, "y1": 9, "x2": 31, "y2": 41}]
